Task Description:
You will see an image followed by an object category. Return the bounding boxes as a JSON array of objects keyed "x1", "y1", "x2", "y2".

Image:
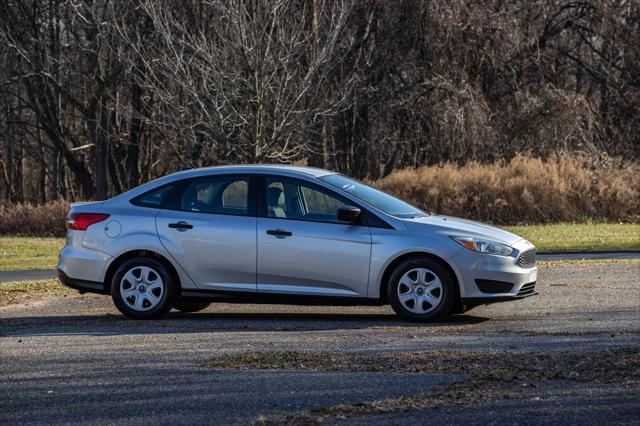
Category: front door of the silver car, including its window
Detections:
[{"x1": 257, "y1": 176, "x2": 371, "y2": 297}]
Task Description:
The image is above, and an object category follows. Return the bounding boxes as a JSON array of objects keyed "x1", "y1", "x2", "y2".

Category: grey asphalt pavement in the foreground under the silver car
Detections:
[{"x1": 0, "y1": 264, "x2": 640, "y2": 424}]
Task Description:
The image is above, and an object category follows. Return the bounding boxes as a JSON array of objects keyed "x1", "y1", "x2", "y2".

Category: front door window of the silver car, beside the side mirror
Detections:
[{"x1": 266, "y1": 178, "x2": 345, "y2": 223}]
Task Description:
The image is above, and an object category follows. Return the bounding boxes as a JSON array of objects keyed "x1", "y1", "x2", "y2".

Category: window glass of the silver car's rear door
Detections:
[{"x1": 180, "y1": 177, "x2": 249, "y2": 215}]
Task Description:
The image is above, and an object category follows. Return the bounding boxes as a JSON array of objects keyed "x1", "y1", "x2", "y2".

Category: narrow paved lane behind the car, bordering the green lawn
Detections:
[{"x1": 0, "y1": 250, "x2": 640, "y2": 284}]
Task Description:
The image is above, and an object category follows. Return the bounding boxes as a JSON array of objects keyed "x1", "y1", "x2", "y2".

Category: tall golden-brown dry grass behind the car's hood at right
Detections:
[{"x1": 372, "y1": 155, "x2": 640, "y2": 224}]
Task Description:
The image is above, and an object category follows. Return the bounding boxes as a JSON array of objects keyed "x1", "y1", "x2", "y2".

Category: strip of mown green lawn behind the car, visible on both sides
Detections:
[{"x1": 0, "y1": 223, "x2": 640, "y2": 270}]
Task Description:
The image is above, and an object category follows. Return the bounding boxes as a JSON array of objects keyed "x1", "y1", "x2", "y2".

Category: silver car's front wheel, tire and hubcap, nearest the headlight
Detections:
[{"x1": 387, "y1": 258, "x2": 457, "y2": 322}]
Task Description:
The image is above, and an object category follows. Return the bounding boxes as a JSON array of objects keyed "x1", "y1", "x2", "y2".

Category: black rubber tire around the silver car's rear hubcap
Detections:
[{"x1": 111, "y1": 257, "x2": 179, "y2": 319}]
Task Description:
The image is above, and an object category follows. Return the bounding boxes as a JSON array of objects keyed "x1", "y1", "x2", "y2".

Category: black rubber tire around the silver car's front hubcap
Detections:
[{"x1": 387, "y1": 258, "x2": 458, "y2": 322}]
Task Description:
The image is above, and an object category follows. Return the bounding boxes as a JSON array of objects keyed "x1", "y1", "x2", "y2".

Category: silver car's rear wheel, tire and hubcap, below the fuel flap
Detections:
[{"x1": 111, "y1": 258, "x2": 178, "y2": 319}]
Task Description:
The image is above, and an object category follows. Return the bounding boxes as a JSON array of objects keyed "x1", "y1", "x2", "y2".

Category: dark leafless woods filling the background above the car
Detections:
[{"x1": 0, "y1": 0, "x2": 640, "y2": 203}]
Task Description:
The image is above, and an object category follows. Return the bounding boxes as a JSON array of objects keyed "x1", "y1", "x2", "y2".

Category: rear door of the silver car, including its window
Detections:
[{"x1": 156, "y1": 175, "x2": 256, "y2": 292}]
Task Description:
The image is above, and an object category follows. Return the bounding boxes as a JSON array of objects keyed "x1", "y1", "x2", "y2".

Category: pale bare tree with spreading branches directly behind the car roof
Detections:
[{"x1": 112, "y1": 0, "x2": 362, "y2": 165}]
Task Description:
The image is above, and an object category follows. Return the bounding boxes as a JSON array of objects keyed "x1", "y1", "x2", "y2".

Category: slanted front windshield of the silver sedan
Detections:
[{"x1": 320, "y1": 175, "x2": 425, "y2": 218}]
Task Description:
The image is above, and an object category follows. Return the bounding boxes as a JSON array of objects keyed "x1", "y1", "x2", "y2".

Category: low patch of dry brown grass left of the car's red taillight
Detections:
[{"x1": 0, "y1": 200, "x2": 69, "y2": 237}]
